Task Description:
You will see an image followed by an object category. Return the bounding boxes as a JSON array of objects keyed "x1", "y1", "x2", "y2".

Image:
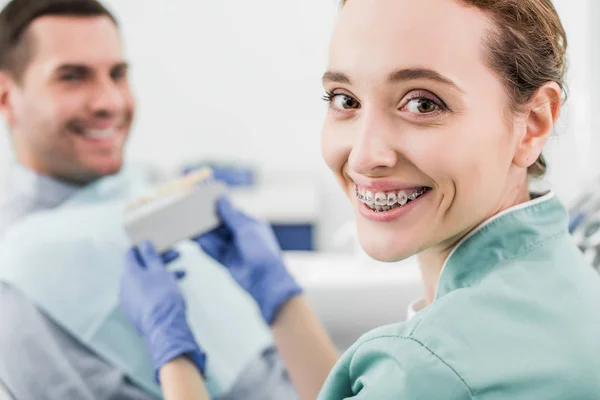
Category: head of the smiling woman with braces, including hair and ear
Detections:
[{"x1": 323, "y1": 0, "x2": 567, "y2": 268}]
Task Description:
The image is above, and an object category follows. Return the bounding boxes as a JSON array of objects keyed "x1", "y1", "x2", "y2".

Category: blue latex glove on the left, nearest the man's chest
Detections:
[{"x1": 120, "y1": 242, "x2": 206, "y2": 377}]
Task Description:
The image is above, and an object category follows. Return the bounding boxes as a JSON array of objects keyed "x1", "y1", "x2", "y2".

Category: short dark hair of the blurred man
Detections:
[{"x1": 0, "y1": 0, "x2": 118, "y2": 80}]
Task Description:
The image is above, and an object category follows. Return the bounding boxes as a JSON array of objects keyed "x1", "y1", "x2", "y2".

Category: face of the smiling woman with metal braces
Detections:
[{"x1": 322, "y1": 0, "x2": 527, "y2": 261}]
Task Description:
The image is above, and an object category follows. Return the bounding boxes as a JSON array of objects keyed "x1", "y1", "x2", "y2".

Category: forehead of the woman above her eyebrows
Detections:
[{"x1": 328, "y1": 0, "x2": 492, "y2": 87}]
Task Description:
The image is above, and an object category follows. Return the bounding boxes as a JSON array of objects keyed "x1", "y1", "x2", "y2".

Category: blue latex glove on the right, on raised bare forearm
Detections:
[{"x1": 195, "y1": 197, "x2": 302, "y2": 325}]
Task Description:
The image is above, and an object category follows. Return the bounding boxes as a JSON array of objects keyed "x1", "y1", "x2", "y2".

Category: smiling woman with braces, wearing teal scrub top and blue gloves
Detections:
[{"x1": 115, "y1": 0, "x2": 600, "y2": 400}]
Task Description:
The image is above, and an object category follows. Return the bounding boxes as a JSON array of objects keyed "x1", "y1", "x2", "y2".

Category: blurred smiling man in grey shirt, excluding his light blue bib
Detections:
[{"x1": 0, "y1": 0, "x2": 294, "y2": 400}]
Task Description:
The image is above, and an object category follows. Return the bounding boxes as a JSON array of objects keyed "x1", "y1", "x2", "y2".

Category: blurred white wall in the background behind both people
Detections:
[{"x1": 0, "y1": 0, "x2": 600, "y2": 251}]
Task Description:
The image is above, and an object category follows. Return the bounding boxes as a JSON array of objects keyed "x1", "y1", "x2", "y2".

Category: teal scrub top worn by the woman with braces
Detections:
[{"x1": 319, "y1": 193, "x2": 600, "y2": 400}]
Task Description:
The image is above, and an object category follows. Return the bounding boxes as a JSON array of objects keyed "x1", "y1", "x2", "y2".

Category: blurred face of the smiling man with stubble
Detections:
[{"x1": 2, "y1": 16, "x2": 135, "y2": 183}]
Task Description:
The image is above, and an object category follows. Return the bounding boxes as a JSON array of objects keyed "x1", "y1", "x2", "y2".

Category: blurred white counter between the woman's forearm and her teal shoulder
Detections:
[{"x1": 285, "y1": 252, "x2": 423, "y2": 349}]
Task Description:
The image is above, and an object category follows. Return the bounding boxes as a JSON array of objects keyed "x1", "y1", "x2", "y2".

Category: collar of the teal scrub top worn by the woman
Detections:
[{"x1": 435, "y1": 192, "x2": 568, "y2": 300}]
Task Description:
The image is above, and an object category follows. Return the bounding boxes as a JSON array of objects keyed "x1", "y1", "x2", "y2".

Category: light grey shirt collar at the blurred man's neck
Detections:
[{"x1": 6, "y1": 164, "x2": 81, "y2": 209}]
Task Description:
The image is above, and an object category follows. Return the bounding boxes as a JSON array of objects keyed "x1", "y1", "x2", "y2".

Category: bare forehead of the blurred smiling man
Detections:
[{"x1": 28, "y1": 16, "x2": 123, "y2": 66}]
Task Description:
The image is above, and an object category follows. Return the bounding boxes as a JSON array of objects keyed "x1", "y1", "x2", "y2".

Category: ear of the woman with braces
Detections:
[{"x1": 513, "y1": 82, "x2": 561, "y2": 168}]
